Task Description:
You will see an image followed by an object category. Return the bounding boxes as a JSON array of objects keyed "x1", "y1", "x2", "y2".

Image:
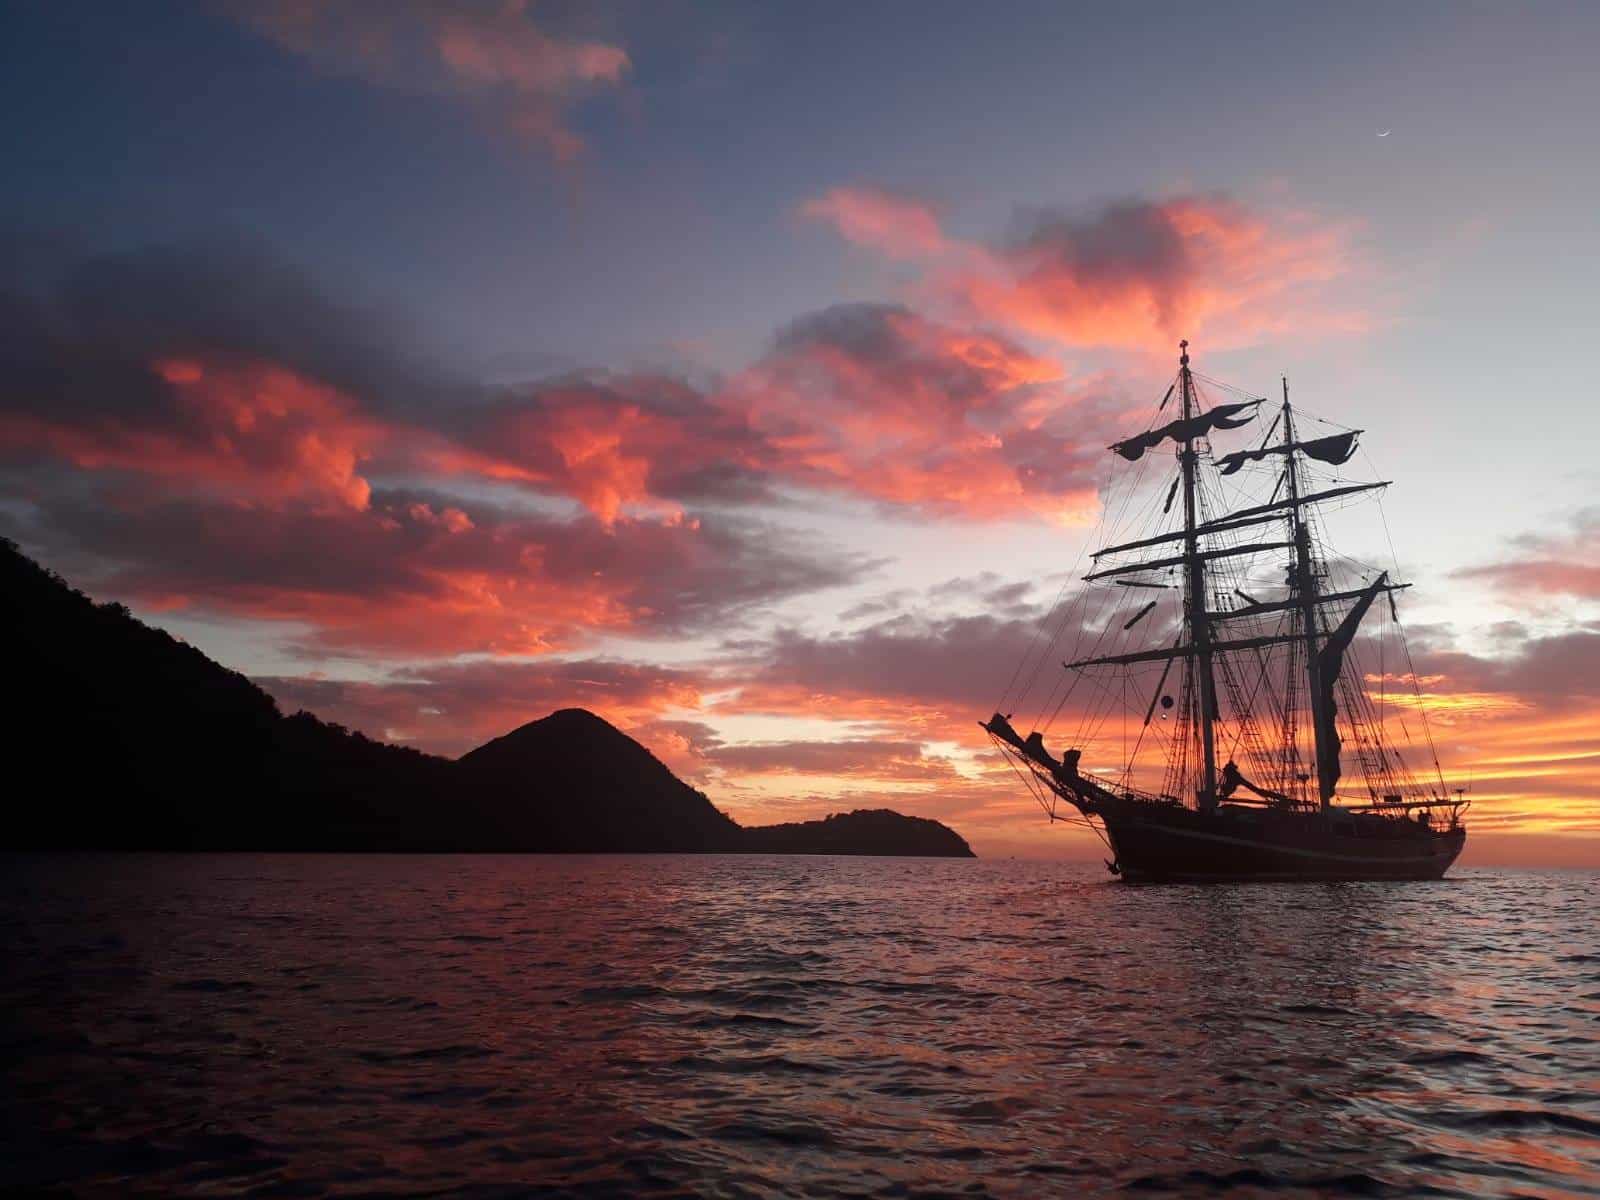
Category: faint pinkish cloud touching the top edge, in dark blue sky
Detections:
[{"x1": 234, "y1": 0, "x2": 630, "y2": 162}]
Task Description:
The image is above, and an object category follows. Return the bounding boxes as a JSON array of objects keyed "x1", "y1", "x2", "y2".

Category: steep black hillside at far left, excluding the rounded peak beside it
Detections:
[{"x1": 0, "y1": 542, "x2": 453, "y2": 850}]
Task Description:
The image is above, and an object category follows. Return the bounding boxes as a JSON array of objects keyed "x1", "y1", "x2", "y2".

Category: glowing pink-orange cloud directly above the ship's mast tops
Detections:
[{"x1": 802, "y1": 189, "x2": 1371, "y2": 350}]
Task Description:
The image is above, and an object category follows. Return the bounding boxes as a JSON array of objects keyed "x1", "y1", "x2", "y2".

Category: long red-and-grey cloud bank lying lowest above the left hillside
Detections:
[{"x1": 25, "y1": 486, "x2": 872, "y2": 656}]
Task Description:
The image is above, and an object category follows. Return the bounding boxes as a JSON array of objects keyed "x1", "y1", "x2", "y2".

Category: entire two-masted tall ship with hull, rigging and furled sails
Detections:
[{"x1": 982, "y1": 341, "x2": 1469, "y2": 883}]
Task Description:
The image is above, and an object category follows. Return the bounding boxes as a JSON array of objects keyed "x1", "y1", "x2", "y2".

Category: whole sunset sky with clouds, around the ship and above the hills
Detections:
[{"x1": 0, "y1": 0, "x2": 1600, "y2": 866}]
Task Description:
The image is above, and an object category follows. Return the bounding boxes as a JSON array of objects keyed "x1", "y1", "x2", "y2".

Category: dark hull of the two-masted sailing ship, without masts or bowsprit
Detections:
[{"x1": 1094, "y1": 803, "x2": 1466, "y2": 883}]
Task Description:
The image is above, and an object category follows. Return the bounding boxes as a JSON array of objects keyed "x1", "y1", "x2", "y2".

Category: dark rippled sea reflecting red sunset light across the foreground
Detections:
[{"x1": 0, "y1": 854, "x2": 1600, "y2": 1197}]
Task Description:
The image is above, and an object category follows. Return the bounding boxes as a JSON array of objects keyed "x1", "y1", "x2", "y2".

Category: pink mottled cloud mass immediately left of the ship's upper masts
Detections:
[{"x1": 725, "y1": 304, "x2": 1120, "y2": 520}]
